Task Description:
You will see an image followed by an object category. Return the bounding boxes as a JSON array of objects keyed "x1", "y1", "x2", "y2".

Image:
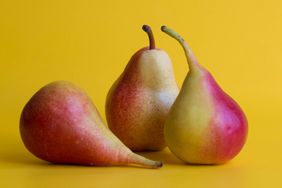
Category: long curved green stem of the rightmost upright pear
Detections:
[{"x1": 161, "y1": 25, "x2": 200, "y2": 71}]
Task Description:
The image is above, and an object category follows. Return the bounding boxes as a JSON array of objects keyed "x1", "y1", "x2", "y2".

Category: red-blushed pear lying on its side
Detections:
[{"x1": 20, "y1": 81, "x2": 162, "y2": 168}]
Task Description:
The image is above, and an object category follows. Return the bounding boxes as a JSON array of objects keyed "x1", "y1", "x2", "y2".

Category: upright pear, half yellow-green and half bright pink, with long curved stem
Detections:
[{"x1": 161, "y1": 26, "x2": 248, "y2": 164}]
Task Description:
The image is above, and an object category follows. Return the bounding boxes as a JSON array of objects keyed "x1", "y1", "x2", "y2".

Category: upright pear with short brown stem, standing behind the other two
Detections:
[{"x1": 106, "y1": 25, "x2": 179, "y2": 151}]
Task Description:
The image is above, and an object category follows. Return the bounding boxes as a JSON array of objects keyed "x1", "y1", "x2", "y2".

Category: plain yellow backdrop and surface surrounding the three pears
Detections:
[{"x1": 0, "y1": 0, "x2": 282, "y2": 187}]
